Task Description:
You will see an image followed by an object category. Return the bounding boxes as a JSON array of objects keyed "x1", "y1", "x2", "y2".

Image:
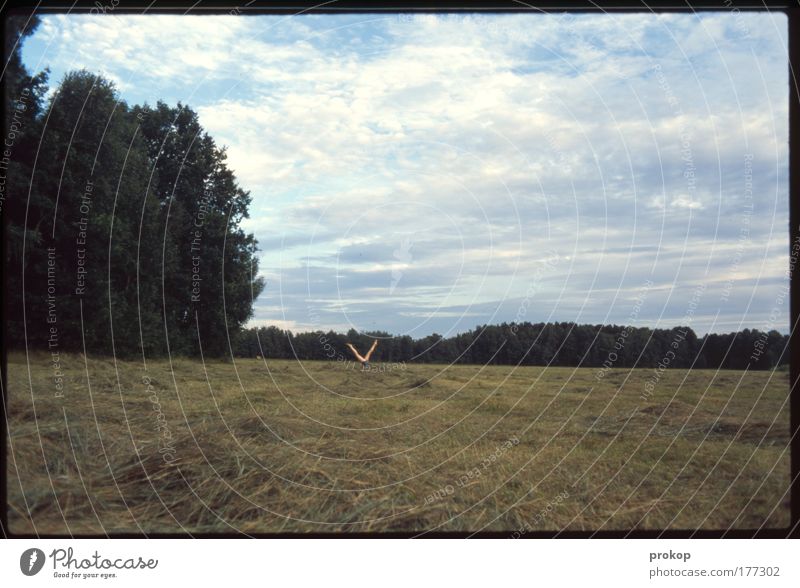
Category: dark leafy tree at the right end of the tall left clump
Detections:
[{"x1": 135, "y1": 101, "x2": 264, "y2": 355}]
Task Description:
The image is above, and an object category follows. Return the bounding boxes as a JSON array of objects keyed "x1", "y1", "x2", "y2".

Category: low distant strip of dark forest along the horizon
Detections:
[{"x1": 233, "y1": 323, "x2": 789, "y2": 370}]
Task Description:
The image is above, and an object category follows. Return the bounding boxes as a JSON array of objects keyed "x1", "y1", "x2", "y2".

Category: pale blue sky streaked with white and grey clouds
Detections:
[{"x1": 23, "y1": 11, "x2": 796, "y2": 337}]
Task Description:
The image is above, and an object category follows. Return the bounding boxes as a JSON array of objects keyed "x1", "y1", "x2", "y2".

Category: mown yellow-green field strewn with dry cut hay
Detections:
[{"x1": 7, "y1": 353, "x2": 789, "y2": 536}]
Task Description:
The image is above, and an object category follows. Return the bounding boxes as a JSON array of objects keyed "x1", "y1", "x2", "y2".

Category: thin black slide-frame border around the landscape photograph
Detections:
[{"x1": 0, "y1": 0, "x2": 800, "y2": 539}]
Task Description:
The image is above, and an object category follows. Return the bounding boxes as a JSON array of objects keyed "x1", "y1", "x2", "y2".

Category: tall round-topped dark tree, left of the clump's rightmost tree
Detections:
[{"x1": 11, "y1": 70, "x2": 166, "y2": 355}]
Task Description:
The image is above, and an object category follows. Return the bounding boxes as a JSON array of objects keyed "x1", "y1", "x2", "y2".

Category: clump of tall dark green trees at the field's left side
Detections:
[{"x1": 0, "y1": 15, "x2": 263, "y2": 356}]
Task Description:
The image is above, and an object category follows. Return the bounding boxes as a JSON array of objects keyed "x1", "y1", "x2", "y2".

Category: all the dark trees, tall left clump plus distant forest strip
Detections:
[{"x1": 1, "y1": 15, "x2": 789, "y2": 369}]
